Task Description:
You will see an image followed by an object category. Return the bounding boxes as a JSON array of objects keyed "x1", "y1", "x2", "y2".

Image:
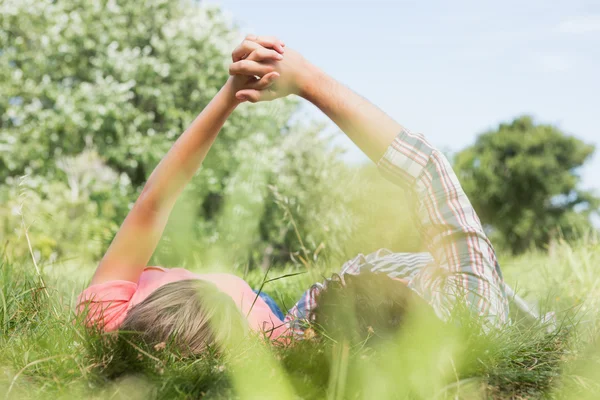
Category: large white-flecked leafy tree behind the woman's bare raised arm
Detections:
[{"x1": 0, "y1": 0, "x2": 360, "y2": 265}]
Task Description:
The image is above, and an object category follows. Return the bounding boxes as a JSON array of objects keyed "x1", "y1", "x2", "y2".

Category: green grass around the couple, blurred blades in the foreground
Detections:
[{"x1": 0, "y1": 239, "x2": 600, "y2": 399}]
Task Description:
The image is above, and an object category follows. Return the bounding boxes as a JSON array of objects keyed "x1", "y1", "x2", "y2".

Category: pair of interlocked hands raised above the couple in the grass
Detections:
[{"x1": 229, "y1": 35, "x2": 312, "y2": 103}]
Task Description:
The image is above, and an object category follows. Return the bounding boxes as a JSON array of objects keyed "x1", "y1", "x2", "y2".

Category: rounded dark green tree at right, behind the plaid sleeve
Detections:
[{"x1": 455, "y1": 116, "x2": 600, "y2": 253}]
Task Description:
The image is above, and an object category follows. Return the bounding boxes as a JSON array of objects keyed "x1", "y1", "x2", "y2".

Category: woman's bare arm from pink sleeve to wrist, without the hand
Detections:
[{"x1": 91, "y1": 85, "x2": 237, "y2": 284}]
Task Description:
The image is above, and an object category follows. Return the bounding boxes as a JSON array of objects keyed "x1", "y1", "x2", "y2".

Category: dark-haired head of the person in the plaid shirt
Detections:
[{"x1": 314, "y1": 272, "x2": 433, "y2": 342}]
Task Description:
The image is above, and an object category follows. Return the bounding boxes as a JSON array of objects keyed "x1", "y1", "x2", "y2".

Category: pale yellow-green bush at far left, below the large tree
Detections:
[{"x1": 0, "y1": 150, "x2": 130, "y2": 261}]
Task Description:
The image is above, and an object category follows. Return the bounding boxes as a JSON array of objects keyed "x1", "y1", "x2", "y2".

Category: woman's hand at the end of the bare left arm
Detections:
[{"x1": 227, "y1": 35, "x2": 285, "y2": 101}]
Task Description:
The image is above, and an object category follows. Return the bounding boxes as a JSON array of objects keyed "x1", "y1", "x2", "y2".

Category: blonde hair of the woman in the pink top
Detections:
[{"x1": 120, "y1": 279, "x2": 247, "y2": 354}]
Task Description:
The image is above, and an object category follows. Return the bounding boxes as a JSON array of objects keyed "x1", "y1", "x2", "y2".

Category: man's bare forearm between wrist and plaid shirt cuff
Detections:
[{"x1": 300, "y1": 65, "x2": 402, "y2": 162}]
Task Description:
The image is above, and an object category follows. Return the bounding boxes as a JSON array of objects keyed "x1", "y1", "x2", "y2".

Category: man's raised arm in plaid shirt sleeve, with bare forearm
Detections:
[{"x1": 232, "y1": 44, "x2": 507, "y2": 322}]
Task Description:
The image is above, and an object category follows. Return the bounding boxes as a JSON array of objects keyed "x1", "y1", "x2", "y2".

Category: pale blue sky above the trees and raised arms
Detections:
[{"x1": 208, "y1": 0, "x2": 600, "y2": 193}]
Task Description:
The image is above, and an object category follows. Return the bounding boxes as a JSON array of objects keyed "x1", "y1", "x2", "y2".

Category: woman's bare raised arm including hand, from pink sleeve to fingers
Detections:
[{"x1": 91, "y1": 37, "x2": 283, "y2": 285}]
